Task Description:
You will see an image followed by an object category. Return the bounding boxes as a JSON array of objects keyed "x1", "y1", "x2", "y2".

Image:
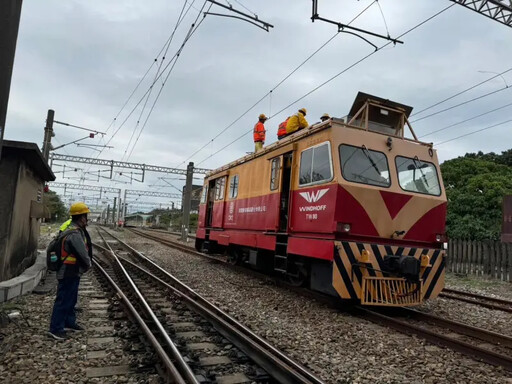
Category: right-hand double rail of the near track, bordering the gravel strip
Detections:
[{"x1": 100, "y1": 229, "x2": 323, "y2": 384}]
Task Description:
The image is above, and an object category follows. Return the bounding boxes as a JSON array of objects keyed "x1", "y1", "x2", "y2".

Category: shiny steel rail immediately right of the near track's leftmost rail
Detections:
[{"x1": 98, "y1": 229, "x2": 199, "y2": 384}]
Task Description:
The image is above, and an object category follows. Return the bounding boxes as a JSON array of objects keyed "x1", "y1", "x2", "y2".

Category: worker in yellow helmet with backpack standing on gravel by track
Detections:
[{"x1": 48, "y1": 202, "x2": 92, "y2": 341}]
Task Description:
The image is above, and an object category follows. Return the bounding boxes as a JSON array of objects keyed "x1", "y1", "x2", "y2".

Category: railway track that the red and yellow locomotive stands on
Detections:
[{"x1": 121, "y1": 225, "x2": 512, "y2": 371}]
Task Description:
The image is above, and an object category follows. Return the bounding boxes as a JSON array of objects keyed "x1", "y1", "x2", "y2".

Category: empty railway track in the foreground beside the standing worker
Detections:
[{"x1": 97, "y1": 229, "x2": 322, "y2": 384}]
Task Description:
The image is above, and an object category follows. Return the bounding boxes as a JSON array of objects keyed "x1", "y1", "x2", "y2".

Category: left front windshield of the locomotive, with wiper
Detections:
[{"x1": 340, "y1": 144, "x2": 391, "y2": 187}]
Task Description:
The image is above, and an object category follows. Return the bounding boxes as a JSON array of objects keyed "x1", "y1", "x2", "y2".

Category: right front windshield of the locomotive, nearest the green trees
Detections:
[{"x1": 395, "y1": 156, "x2": 441, "y2": 196}]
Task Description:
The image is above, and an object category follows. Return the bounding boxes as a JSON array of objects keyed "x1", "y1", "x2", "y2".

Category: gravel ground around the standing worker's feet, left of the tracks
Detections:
[{"x1": 0, "y1": 236, "x2": 161, "y2": 384}]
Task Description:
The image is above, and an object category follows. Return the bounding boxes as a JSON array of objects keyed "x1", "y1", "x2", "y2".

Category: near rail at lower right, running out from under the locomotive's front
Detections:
[{"x1": 357, "y1": 307, "x2": 512, "y2": 371}]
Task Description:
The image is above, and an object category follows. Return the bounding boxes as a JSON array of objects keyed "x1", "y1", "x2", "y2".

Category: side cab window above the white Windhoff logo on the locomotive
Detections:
[{"x1": 299, "y1": 142, "x2": 332, "y2": 186}]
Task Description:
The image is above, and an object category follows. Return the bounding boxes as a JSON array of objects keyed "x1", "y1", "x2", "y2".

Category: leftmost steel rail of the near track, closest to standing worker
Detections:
[{"x1": 92, "y1": 260, "x2": 187, "y2": 384}]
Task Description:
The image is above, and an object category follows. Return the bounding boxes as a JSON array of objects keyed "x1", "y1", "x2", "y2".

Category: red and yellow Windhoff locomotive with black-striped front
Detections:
[{"x1": 196, "y1": 93, "x2": 446, "y2": 306}]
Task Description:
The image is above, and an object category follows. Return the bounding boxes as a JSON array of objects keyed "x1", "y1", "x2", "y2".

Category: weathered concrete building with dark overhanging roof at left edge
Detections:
[{"x1": 0, "y1": 140, "x2": 55, "y2": 281}]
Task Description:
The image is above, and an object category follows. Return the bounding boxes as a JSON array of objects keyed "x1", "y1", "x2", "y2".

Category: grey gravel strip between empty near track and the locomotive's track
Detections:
[{"x1": 113, "y1": 233, "x2": 512, "y2": 383}]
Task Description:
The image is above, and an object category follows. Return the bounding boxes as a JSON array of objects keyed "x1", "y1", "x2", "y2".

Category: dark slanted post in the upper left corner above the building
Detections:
[{"x1": 0, "y1": 0, "x2": 23, "y2": 159}]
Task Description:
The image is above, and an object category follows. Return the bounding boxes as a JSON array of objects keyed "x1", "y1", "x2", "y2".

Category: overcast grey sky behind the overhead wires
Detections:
[{"x1": 5, "y1": 0, "x2": 512, "y2": 210}]
